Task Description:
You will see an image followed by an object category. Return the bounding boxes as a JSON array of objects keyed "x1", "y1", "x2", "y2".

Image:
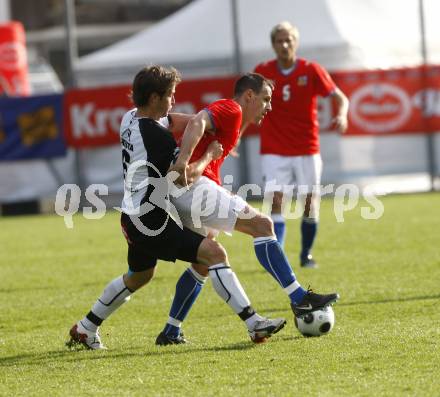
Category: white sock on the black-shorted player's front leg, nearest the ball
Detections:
[{"x1": 209, "y1": 263, "x2": 251, "y2": 314}]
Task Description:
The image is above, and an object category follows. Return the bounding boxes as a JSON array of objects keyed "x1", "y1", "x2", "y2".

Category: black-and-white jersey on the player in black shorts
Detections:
[{"x1": 119, "y1": 108, "x2": 177, "y2": 216}]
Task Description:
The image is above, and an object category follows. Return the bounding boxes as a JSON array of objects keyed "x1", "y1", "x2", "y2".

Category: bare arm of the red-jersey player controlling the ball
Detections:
[{"x1": 172, "y1": 110, "x2": 213, "y2": 186}]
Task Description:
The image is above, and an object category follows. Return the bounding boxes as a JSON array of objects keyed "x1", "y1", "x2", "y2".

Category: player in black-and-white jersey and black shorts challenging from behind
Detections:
[{"x1": 68, "y1": 66, "x2": 286, "y2": 350}]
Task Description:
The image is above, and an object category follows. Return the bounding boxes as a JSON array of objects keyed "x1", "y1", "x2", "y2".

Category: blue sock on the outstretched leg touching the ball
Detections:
[{"x1": 254, "y1": 237, "x2": 306, "y2": 304}]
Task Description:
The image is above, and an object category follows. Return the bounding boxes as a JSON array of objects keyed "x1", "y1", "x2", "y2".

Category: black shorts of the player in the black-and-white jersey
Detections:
[{"x1": 121, "y1": 213, "x2": 204, "y2": 272}]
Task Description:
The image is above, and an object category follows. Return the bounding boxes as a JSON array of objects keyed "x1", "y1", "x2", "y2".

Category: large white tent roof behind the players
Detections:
[{"x1": 76, "y1": 0, "x2": 440, "y2": 86}]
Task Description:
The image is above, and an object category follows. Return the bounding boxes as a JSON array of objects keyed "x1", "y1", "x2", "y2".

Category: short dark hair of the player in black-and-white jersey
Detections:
[{"x1": 131, "y1": 65, "x2": 181, "y2": 107}]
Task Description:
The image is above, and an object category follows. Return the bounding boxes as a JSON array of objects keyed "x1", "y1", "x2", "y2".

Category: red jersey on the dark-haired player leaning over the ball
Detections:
[{"x1": 190, "y1": 99, "x2": 242, "y2": 185}]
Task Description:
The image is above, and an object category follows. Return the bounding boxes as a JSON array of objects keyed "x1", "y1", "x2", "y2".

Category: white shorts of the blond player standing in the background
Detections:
[{"x1": 261, "y1": 154, "x2": 322, "y2": 193}]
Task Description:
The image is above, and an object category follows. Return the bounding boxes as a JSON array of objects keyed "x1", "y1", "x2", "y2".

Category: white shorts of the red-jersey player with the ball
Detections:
[{"x1": 170, "y1": 176, "x2": 247, "y2": 236}]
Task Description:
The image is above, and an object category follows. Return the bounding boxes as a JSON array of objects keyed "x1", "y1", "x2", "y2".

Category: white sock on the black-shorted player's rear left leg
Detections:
[{"x1": 92, "y1": 276, "x2": 132, "y2": 320}]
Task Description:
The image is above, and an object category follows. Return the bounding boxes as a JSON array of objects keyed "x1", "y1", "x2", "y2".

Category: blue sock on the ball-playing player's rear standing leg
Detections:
[{"x1": 163, "y1": 267, "x2": 207, "y2": 336}]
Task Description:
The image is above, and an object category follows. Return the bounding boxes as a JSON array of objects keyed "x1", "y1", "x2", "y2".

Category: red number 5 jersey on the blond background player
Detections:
[{"x1": 255, "y1": 58, "x2": 336, "y2": 156}]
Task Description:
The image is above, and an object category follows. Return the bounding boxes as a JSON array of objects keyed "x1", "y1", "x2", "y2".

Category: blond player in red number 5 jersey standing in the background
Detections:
[{"x1": 255, "y1": 22, "x2": 348, "y2": 267}]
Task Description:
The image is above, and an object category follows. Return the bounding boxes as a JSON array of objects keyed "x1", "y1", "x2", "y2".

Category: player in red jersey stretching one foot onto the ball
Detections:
[{"x1": 156, "y1": 73, "x2": 339, "y2": 345}]
